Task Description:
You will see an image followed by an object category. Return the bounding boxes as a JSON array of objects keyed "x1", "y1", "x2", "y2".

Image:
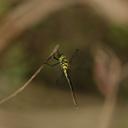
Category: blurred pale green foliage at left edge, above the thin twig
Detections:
[{"x1": 0, "y1": 43, "x2": 28, "y2": 95}]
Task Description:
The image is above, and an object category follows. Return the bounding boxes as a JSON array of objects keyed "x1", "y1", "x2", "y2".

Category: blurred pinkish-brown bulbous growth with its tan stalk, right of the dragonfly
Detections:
[{"x1": 94, "y1": 46, "x2": 122, "y2": 128}]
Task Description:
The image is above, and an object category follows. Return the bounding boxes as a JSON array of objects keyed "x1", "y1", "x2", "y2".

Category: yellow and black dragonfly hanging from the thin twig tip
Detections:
[{"x1": 46, "y1": 46, "x2": 78, "y2": 106}]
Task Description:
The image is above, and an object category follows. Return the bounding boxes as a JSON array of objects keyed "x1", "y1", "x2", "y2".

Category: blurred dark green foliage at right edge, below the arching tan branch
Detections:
[{"x1": 106, "y1": 25, "x2": 128, "y2": 63}]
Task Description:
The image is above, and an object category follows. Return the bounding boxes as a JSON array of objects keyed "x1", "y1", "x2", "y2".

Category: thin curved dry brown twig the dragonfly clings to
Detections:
[{"x1": 0, "y1": 45, "x2": 59, "y2": 104}]
